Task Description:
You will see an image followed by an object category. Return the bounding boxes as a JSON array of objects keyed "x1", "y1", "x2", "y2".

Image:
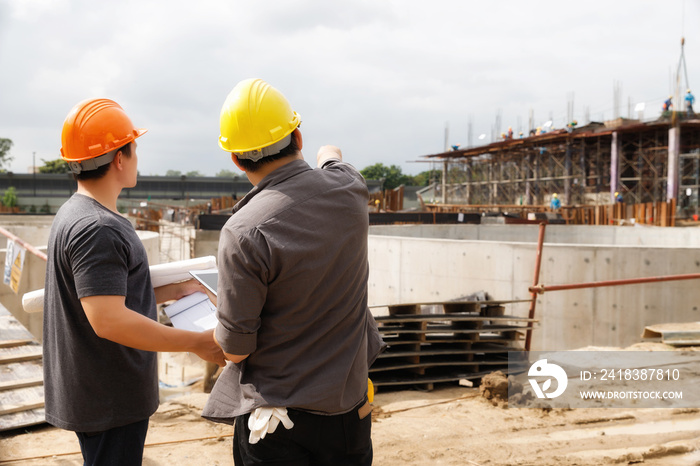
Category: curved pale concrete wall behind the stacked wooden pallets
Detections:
[{"x1": 369, "y1": 225, "x2": 700, "y2": 350}]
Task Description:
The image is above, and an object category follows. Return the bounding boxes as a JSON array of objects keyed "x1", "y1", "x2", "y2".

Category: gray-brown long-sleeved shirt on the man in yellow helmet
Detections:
[{"x1": 203, "y1": 160, "x2": 383, "y2": 422}]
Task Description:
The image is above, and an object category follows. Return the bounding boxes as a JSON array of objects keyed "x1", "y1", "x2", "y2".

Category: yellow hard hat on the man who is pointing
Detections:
[{"x1": 219, "y1": 79, "x2": 301, "y2": 162}]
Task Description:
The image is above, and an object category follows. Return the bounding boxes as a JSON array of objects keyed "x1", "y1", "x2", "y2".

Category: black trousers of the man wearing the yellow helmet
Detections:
[{"x1": 233, "y1": 402, "x2": 372, "y2": 466}]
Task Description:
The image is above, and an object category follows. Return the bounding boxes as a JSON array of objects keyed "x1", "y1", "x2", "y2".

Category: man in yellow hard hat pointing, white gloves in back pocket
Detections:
[{"x1": 202, "y1": 79, "x2": 385, "y2": 465}]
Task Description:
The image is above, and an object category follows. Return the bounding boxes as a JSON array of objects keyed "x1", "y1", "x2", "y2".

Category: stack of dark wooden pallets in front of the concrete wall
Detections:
[{"x1": 369, "y1": 301, "x2": 534, "y2": 390}]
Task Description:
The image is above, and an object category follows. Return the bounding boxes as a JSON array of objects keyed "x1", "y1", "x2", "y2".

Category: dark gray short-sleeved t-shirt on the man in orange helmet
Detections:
[{"x1": 43, "y1": 194, "x2": 158, "y2": 432}]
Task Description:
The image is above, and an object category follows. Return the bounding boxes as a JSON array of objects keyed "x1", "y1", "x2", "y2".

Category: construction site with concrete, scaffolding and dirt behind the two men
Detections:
[{"x1": 0, "y1": 33, "x2": 700, "y2": 466}]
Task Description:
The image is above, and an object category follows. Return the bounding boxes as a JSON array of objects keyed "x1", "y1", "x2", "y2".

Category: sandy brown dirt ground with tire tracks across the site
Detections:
[{"x1": 0, "y1": 344, "x2": 700, "y2": 466}]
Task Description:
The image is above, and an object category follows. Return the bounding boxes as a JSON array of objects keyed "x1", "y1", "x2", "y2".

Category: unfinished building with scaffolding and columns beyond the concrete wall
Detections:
[{"x1": 426, "y1": 112, "x2": 700, "y2": 217}]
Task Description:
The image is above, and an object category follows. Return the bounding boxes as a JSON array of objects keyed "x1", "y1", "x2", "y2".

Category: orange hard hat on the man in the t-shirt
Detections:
[{"x1": 61, "y1": 99, "x2": 148, "y2": 169}]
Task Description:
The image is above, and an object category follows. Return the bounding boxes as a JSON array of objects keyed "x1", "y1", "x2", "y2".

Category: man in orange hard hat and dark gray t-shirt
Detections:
[{"x1": 43, "y1": 99, "x2": 225, "y2": 465}]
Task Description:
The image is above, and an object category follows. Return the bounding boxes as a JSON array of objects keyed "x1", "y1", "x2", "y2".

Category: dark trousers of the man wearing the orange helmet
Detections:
[{"x1": 75, "y1": 419, "x2": 148, "y2": 466}]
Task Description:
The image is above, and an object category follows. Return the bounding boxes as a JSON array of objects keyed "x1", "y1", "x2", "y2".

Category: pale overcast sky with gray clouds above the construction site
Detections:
[{"x1": 0, "y1": 0, "x2": 700, "y2": 176}]
